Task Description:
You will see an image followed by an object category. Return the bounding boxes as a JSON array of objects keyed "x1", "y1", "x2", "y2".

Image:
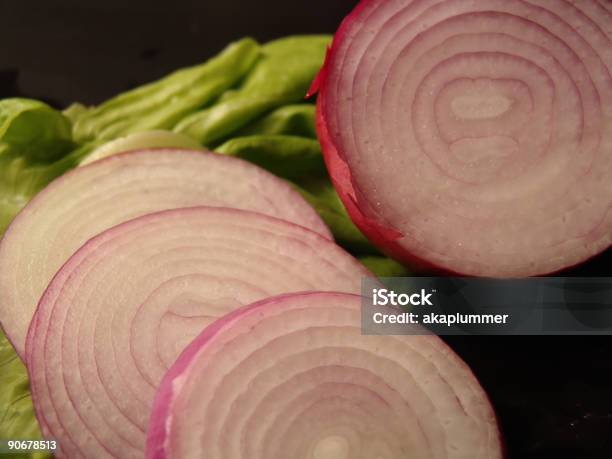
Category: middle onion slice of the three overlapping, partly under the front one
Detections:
[{"x1": 26, "y1": 207, "x2": 368, "y2": 459}]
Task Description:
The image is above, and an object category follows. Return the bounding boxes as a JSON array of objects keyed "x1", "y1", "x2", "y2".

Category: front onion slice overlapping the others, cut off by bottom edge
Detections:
[{"x1": 146, "y1": 293, "x2": 502, "y2": 459}]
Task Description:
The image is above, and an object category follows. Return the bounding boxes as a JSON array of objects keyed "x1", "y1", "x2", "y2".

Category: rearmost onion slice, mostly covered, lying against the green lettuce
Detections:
[{"x1": 0, "y1": 149, "x2": 332, "y2": 356}]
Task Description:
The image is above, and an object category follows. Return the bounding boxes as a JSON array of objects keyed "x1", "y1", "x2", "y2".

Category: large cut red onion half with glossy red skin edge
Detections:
[{"x1": 314, "y1": 0, "x2": 612, "y2": 277}]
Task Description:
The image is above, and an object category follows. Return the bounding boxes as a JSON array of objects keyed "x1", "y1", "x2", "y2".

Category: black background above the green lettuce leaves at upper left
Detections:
[{"x1": 0, "y1": 0, "x2": 356, "y2": 106}]
